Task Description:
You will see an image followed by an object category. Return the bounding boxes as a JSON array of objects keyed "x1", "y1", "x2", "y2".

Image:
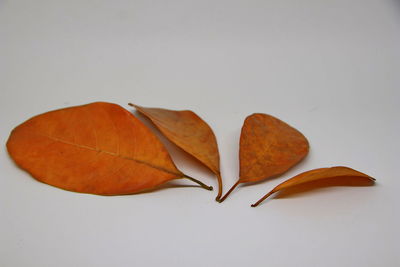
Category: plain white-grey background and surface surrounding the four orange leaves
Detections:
[{"x1": 0, "y1": 0, "x2": 400, "y2": 267}]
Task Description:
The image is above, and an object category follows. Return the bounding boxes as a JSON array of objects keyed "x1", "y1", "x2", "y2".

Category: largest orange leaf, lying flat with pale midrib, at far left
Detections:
[{"x1": 7, "y1": 102, "x2": 210, "y2": 195}]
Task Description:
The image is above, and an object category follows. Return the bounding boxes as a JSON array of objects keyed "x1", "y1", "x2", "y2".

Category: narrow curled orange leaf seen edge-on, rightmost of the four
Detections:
[{"x1": 251, "y1": 167, "x2": 375, "y2": 207}]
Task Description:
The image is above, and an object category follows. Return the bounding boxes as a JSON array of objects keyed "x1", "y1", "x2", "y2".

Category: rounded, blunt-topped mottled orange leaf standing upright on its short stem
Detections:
[{"x1": 220, "y1": 113, "x2": 309, "y2": 202}]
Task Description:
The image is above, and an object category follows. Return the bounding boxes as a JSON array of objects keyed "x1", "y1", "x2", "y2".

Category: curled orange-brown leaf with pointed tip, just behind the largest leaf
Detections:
[{"x1": 129, "y1": 103, "x2": 222, "y2": 200}]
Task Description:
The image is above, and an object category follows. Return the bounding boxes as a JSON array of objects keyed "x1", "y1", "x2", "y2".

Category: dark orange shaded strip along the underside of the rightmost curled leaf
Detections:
[{"x1": 274, "y1": 177, "x2": 375, "y2": 198}]
